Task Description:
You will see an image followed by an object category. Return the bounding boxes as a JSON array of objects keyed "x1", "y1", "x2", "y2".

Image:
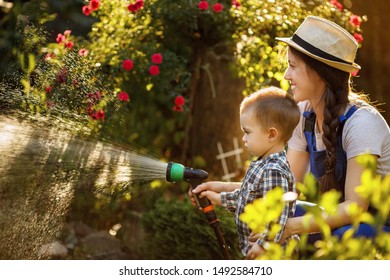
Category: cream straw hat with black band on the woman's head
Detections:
[{"x1": 276, "y1": 16, "x2": 360, "y2": 73}]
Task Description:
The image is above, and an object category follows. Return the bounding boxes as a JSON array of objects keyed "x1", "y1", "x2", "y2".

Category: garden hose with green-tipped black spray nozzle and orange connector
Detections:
[{"x1": 166, "y1": 162, "x2": 230, "y2": 260}]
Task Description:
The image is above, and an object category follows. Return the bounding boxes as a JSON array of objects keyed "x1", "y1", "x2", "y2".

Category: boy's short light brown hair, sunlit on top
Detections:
[{"x1": 240, "y1": 87, "x2": 301, "y2": 143}]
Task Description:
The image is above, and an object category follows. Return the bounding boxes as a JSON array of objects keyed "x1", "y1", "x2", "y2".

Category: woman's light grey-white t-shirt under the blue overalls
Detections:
[{"x1": 288, "y1": 101, "x2": 390, "y2": 175}]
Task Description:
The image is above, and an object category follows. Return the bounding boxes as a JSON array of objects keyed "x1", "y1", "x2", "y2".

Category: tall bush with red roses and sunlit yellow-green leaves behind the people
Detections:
[{"x1": 19, "y1": 0, "x2": 365, "y2": 167}]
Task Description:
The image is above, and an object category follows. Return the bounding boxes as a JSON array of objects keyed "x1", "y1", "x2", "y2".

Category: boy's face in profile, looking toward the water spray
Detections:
[{"x1": 240, "y1": 109, "x2": 273, "y2": 157}]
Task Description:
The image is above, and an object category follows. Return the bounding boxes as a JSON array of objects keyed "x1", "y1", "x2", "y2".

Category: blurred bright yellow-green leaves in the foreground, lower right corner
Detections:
[{"x1": 241, "y1": 155, "x2": 390, "y2": 260}]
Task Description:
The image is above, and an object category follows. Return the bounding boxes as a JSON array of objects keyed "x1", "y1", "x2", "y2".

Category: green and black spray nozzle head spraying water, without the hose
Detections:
[{"x1": 166, "y1": 162, "x2": 209, "y2": 182}]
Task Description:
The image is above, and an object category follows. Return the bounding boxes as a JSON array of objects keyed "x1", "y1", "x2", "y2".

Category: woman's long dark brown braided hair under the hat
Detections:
[{"x1": 290, "y1": 48, "x2": 351, "y2": 193}]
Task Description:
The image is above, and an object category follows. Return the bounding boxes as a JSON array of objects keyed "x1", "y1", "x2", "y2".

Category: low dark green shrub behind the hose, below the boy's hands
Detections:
[{"x1": 143, "y1": 196, "x2": 241, "y2": 260}]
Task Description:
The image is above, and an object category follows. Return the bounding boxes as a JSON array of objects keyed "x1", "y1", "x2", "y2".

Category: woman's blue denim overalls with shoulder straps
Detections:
[{"x1": 295, "y1": 106, "x2": 390, "y2": 242}]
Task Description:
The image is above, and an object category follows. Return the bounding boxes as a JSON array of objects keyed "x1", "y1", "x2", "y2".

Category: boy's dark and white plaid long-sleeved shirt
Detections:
[{"x1": 221, "y1": 150, "x2": 296, "y2": 256}]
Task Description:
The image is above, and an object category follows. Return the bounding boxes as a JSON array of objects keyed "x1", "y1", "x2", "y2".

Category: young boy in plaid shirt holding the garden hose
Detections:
[{"x1": 194, "y1": 87, "x2": 300, "y2": 259}]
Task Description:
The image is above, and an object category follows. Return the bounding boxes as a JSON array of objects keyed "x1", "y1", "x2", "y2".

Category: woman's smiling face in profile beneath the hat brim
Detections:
[{"x1": 284, "y1": 48, "x2": 325, "y2": 104}]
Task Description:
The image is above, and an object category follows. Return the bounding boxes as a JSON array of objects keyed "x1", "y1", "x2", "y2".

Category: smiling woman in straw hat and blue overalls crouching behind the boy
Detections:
[{"x1": 194, "y1": 16, "x2": 390, "y2": 245}]
